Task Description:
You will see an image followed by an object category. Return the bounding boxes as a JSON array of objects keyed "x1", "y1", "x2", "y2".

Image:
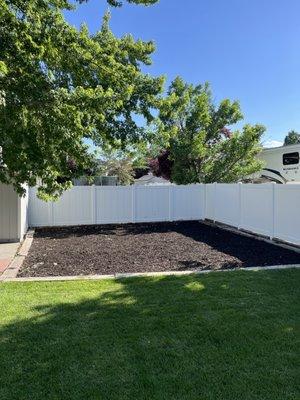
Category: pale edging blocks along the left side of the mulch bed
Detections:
[{"x1": 0, "y1": 229, "x2": 35, "y2": 281}]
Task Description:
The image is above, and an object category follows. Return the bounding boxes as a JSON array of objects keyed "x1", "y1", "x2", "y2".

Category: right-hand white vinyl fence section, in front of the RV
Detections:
[{"x1": 205, "y1": 183, "x2": 300, "y2": 245}]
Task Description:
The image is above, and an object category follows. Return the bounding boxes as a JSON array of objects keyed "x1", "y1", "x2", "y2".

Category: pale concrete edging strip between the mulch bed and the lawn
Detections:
[{"x1": 0, "y1": 264, "x2": 300, "y2": 282}]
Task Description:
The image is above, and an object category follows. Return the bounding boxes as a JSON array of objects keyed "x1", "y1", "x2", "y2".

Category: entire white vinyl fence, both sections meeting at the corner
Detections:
[{"x1": 29, "y1": 183, "x2": 300, "y2": 245}]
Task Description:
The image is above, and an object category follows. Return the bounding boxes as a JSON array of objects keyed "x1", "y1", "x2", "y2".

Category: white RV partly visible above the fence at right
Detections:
[{"x1": 254, "y1": 144, "x2": 300, "y2": 183}]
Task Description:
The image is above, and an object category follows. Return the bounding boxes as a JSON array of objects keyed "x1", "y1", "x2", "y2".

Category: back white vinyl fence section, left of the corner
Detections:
[{"x1": 29, "y1": 185, "x2": 205, "y2": 227}]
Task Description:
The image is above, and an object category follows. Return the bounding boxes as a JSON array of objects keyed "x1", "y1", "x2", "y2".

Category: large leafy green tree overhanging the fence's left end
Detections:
[{"x1": 0, "y1": 0, "x2": 163, "y2": 198}]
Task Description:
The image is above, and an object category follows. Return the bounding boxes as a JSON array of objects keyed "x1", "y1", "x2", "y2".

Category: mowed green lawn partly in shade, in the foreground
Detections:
[{"x1": 0, "y1": 270, "x2": 300, "y2": 400}]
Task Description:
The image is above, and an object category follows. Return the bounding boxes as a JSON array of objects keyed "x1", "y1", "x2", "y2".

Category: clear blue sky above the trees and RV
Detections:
[{"x1": 66, "y1": 0, "x2": 300, "y2": 145}]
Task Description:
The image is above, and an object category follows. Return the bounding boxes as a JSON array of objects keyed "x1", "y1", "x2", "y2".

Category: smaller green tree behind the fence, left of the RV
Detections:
[{"x1": 154, "y1": 78, "x2": 264, "y2": 184}]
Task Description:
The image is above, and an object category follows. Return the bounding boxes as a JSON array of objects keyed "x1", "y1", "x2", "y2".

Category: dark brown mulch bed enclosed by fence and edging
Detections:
[{"x1": 18, "y1": 221, "x2": 300, "y2": 276}]
